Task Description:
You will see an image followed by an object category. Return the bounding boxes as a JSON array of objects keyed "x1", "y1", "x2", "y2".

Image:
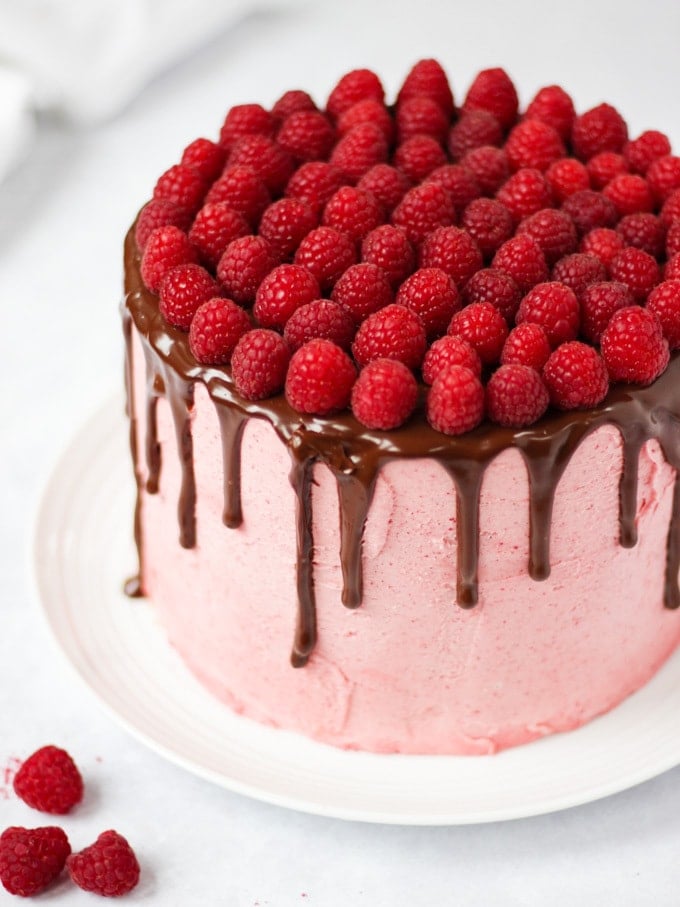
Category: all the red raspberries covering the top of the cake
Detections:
[{"x1": 135, "y1": 60, "x2": 680, "y2": 435}]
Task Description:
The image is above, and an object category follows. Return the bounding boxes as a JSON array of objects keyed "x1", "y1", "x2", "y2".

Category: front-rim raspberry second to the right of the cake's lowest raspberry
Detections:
[{"x1": 543, "y1": 340, "x2": 609, "y2": 410}]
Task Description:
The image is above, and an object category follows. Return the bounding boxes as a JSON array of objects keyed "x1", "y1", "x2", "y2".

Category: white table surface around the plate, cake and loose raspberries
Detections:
[{"x1": 0, "y1": 0, "x2": 680, "y2": 907}]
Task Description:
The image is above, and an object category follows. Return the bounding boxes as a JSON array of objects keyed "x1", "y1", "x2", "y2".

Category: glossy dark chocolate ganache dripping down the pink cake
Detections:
[{"x1": 123, "y1": 230, "x2": 680, "y2": 667}]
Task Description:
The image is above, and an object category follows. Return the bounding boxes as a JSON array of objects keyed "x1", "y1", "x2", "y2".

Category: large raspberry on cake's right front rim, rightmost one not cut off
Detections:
[{"x1": 601, "y1": 305, "x2": 670, "y2": 385}]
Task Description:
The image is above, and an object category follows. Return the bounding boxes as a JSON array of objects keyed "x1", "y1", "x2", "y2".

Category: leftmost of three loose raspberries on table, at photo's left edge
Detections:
[{"x1": 0, "y1": 825, "x2": 71, "y2": 898}]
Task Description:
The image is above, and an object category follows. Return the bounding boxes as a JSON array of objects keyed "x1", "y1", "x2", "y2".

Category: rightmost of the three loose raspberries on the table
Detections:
[{"x1": 66, "y1": 830, "x2": 139, "y2": 897}]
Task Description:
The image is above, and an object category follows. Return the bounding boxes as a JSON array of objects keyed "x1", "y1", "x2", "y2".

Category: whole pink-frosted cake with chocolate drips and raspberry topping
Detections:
[{"x1": 122, "y1": 60, "x2": 680, "y2": 754}]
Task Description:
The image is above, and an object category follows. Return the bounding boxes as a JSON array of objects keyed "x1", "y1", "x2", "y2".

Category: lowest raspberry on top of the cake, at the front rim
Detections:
[{"x1": 427, "y1": 365, "x2": 484, "y2": 435}]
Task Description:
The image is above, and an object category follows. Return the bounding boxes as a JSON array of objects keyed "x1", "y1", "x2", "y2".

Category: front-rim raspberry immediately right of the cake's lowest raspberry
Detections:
[{"x1": 486, "y1": 363, "x2": 549, "y2": 428}]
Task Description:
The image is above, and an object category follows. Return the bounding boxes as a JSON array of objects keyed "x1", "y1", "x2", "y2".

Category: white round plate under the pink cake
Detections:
[{"x1": 36, "y1": 399, "x2": 680, "y2": 825}]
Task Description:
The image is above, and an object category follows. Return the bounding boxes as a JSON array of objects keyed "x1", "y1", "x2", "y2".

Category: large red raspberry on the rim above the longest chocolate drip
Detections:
[{"x1": 286, "y1": 339, "x2": 357, "y2": 416}]
